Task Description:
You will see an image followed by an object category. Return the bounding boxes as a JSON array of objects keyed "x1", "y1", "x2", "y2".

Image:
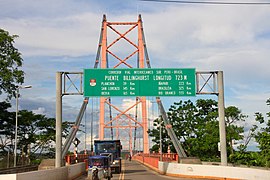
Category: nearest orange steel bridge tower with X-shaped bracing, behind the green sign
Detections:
[{"x1": 94, "y1": 15, "x2": 150, "y2": 153}]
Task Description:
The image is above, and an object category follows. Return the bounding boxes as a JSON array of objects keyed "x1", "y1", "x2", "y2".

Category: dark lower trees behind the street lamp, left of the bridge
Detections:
[{"x1": 0, "y1": 102, "x2": 70, "y2": 161}]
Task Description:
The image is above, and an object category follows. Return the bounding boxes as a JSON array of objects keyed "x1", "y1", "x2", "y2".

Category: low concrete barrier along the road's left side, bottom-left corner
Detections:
[{"x1": 0, "y1": 162, "x2": 86, "y2": 180}]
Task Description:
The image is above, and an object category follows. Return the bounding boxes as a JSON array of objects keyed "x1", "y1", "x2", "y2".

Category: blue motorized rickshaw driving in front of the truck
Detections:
[{"x1": 88, "y1": 155, "x2": 112, "y2": 180}]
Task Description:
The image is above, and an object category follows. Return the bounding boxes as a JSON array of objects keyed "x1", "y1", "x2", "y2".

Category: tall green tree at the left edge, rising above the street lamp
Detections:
[{"x1": 0, "y1": 29, "x2": 24, "y2": 99}]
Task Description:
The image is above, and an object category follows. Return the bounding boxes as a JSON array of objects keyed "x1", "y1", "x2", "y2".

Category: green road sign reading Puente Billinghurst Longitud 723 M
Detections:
[{"x1": 84, "y1": 68, "x2": 196, "y2": 97}]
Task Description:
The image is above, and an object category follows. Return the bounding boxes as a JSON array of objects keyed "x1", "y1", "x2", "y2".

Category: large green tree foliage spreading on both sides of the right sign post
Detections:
[{"x1": 149, "y1": 99, "x2": 245, "y2": 160}]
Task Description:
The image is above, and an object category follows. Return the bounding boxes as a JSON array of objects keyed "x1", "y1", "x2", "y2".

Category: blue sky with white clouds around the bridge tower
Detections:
[{"x1": 0, "y1": 0, "x2": 270, "y2": 151}]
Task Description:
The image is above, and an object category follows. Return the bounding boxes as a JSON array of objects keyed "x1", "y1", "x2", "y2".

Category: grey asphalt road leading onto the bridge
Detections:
[{"x1": 79, "y1": 160, "x2": 210, "y2": 180}]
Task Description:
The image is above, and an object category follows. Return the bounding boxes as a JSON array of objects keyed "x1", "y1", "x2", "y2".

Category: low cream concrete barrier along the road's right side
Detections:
[{"x1": 158, "y1": 161, "x2": 270, "y2": 180}]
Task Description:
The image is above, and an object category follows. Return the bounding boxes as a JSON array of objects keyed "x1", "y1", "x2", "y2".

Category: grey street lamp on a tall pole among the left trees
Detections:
[{"x1": 14, "y1": 85, "x2": 32, "y2": 167}]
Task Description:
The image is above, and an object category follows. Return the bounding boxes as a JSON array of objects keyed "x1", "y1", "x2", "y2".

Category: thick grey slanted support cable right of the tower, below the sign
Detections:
[{"x1": 156, "y1": 97, "x2": 187, "y2": 157}]
